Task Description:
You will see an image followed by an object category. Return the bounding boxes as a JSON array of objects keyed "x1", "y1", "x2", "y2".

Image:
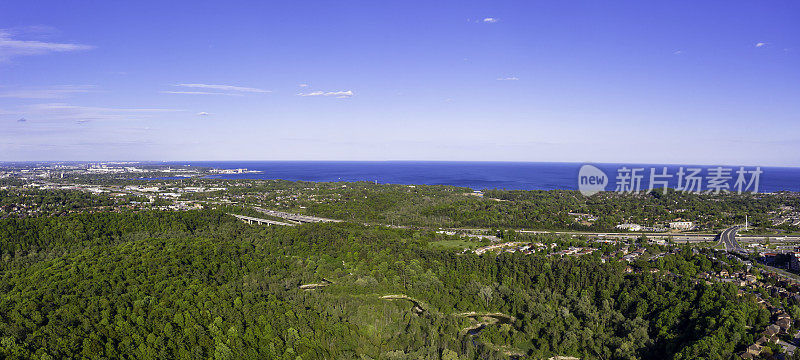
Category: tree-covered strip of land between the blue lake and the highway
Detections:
[{"x1": 183, "y1": 180, "x2": 798, "y2": 231}]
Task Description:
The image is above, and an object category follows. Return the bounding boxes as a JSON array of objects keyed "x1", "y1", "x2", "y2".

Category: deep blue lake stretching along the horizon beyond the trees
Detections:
[{"x1": 164, "y1": 161, "x2": 800, "y2": 192}]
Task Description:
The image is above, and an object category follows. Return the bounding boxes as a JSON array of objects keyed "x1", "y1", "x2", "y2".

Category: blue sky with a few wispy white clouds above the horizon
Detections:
[{"x1": 0, "y1": 0, "x2": 800, "y2": 166}]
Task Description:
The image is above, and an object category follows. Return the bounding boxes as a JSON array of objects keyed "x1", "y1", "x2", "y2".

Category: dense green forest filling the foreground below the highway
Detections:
[{"x1": 0, "y1": 210, "x2": 769, "y2": 360}]
